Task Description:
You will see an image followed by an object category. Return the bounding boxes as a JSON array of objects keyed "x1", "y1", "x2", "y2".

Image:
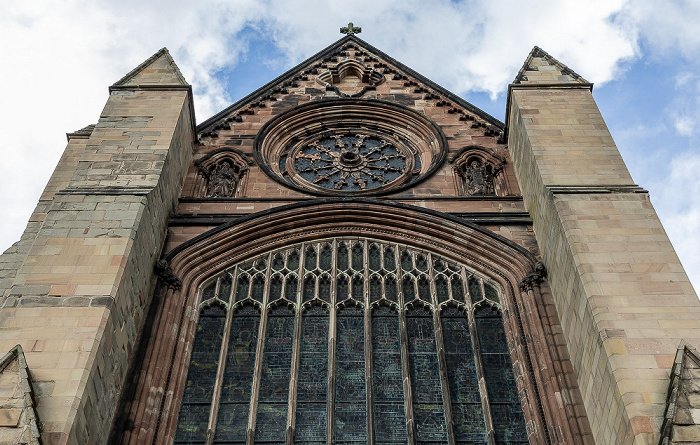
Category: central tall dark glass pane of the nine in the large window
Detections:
[{"x1": 335, "y1": 307, "x2": 367, "y2": 443}]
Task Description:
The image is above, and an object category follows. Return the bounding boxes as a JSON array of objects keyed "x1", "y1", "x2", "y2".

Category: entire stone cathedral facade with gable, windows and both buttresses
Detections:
[{"x1": 0, "y1": 32, "x2": 700, "y2": 445}]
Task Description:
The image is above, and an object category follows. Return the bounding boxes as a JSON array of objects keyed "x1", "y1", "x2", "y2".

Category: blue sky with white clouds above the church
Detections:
[{"x1": 0, "y1": 0, "x2": 700, "y2": 289}]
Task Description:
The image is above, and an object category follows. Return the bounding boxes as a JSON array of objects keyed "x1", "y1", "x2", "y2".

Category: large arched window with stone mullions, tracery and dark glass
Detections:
[{"x1": 174, "y1": 238, "x2": 528, "y2": 445}]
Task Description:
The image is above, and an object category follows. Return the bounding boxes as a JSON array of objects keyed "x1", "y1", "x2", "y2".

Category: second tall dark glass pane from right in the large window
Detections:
[{"x1": 441, "y1": 308, "x2": 487, "y2": 443}]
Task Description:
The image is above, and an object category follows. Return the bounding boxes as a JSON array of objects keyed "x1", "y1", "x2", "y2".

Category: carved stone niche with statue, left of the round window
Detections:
[{"x1": 192, "y1": 147, "x2": 252, "y2": 198}]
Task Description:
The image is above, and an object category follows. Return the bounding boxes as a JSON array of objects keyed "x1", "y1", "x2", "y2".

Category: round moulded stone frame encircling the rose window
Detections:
[{"x1": 254, "y1": 99, "x2": 447, "y2": 196}]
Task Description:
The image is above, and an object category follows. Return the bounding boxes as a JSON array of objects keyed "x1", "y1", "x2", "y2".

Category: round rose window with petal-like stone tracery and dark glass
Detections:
[{"x1": 286, "y1": 132, "x2": 420, "y2": 191}]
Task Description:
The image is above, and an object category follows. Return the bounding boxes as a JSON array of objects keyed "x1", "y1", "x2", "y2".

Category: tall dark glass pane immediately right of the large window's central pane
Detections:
[{"x1": 372, "y1": 306, "x2": 406, "y2": 444}]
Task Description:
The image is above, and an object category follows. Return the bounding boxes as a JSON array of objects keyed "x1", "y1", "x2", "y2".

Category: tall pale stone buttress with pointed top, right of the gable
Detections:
[{"x1": 506, "y1": 48, "x2": 700, "y2": 445}]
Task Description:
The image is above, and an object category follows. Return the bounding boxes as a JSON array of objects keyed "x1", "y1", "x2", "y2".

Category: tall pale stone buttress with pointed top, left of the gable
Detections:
[{"x1": 0, "y1": 49, "x2": 195, "y2": 444}]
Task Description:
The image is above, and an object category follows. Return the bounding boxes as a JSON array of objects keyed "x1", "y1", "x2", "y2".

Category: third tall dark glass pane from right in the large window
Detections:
[{"x1": 406, "y1": 308, "x2": 447, "y2": 443}]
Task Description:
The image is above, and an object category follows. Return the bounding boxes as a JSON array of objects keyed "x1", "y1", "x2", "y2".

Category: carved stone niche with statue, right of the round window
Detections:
[{"x1": 450, "y1": 145, "x2": 510, "y2": 196}]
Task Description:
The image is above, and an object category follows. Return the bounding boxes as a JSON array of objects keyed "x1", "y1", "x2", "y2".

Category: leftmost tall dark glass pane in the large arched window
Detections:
[{"x1": 175, "y1": 305, "x2": 226, "y2": 443}]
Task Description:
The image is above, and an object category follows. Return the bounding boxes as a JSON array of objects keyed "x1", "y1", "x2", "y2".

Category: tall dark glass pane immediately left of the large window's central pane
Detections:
[{"x1": 294, "y1": 307, "x2": 329, "y2": 443}]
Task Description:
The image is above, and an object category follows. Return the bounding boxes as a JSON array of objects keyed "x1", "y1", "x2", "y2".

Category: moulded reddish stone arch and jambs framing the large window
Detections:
[{"x1": 113, "y1": 199, "x2": 588, "y2": 444}]
